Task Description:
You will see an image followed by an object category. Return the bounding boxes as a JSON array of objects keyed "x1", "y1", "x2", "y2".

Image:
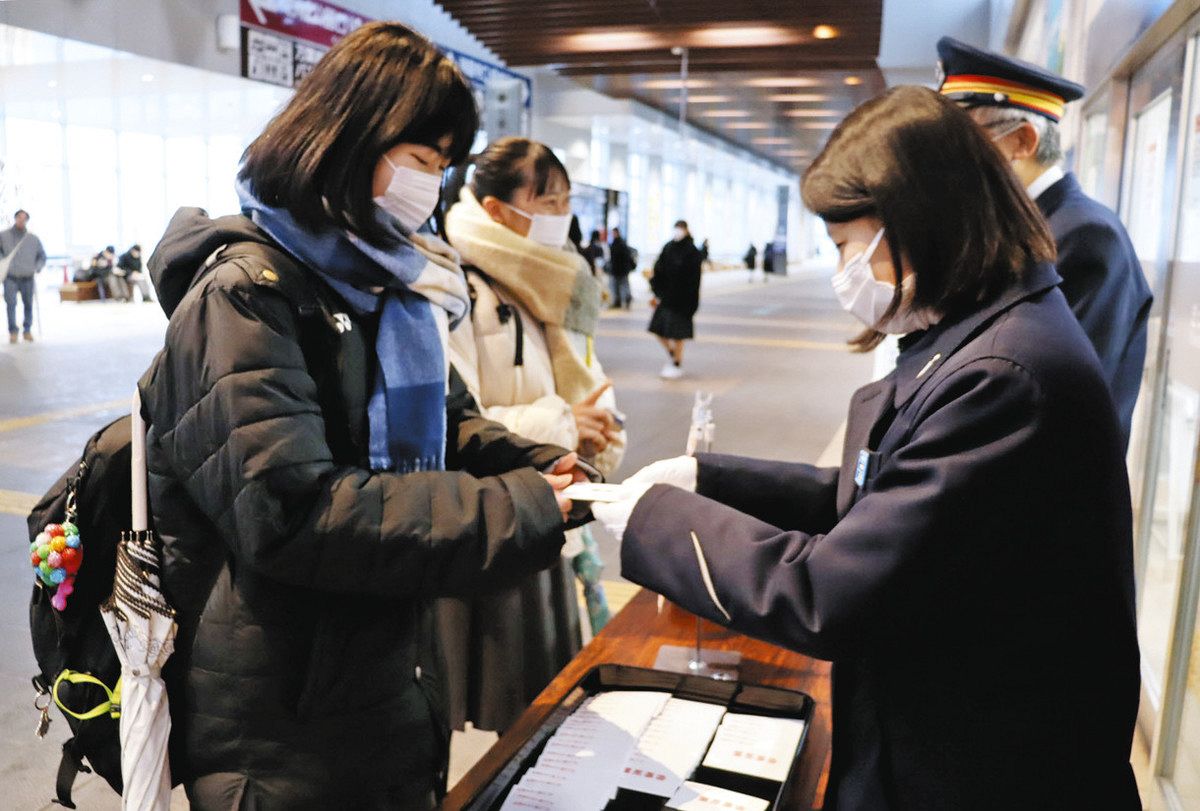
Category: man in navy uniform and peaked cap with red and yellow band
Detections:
[{"x1": 937, "y1": 37, "x2": 1152, "y2": 445}]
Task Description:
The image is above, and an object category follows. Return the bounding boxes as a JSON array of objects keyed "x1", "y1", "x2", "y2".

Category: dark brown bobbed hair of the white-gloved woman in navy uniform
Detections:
[{"x1": 800, "y1": 86, "x2": 1055, "y2": 352}]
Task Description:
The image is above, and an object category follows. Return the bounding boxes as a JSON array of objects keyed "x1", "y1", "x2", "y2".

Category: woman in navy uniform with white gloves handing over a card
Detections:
[{"x1": 593, "y1": 86, "x2": 1139, "y2": 811}]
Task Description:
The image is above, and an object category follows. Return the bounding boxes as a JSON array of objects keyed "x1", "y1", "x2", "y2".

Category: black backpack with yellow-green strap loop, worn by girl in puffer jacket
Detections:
[{"x1": 28, "y1": 242, "x2": 307, "y2": 809}]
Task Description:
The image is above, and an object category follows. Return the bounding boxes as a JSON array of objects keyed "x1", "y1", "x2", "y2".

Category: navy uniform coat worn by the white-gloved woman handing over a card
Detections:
[{"x1": 622, "y1": 265, "x2": 1140, "y2": 811}]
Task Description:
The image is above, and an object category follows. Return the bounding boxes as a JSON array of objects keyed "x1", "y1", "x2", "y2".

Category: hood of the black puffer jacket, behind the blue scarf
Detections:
[{"x1": 146, "y1": 208, "x2": 274, "y2": 318}]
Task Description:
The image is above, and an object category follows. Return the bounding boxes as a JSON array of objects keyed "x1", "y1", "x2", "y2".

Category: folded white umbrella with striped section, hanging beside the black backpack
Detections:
[{"x1": 101, "y1": 394, "x2": 176, "y2": 811}]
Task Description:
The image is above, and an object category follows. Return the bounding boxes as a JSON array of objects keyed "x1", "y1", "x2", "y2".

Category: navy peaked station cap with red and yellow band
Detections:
[{"x1": 937, "y1": 37, "x2": 1084, "y2": 122}]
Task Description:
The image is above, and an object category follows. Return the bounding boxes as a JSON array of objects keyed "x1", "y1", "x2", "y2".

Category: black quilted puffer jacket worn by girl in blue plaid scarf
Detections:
[{"x1": 142, "y1": 209, "x2": 565, "y2": 809}]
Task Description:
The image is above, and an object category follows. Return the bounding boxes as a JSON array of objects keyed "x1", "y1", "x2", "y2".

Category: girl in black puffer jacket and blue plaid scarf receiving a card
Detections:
[{"x1": 140, "y1": 23, "x2": 582, "y2": 809}]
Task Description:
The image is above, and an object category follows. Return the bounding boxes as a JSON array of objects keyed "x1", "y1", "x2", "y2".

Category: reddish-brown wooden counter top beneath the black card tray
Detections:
[{"x1": 442, "y1": 590, "x2": 829, "y2": 811}]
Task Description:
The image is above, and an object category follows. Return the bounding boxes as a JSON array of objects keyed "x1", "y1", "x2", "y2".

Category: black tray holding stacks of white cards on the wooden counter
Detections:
[{"x1": 464, "y1": 665, "x2": 814, "y2": 811}]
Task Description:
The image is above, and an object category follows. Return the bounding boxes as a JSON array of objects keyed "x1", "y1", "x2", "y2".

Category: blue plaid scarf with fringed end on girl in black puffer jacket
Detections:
[{"x1": 238, "y1": 181, "x2": 469, "y2": 473}]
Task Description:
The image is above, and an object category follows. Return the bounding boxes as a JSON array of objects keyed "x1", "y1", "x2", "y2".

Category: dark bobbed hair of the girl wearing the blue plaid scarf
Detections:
[{"x1": 239, "y1": 23, "x2": 479, "y2": 247}]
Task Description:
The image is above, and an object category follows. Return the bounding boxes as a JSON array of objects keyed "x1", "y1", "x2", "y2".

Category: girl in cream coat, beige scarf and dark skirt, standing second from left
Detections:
[{"x1": 438, "y1": 138, "x2": 625, "y2": 731}]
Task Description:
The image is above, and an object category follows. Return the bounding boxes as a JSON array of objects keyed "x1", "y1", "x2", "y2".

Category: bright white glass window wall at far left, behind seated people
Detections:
[{"x1": 0, "y1": 25, "x2": 290, "y2": 260}]
